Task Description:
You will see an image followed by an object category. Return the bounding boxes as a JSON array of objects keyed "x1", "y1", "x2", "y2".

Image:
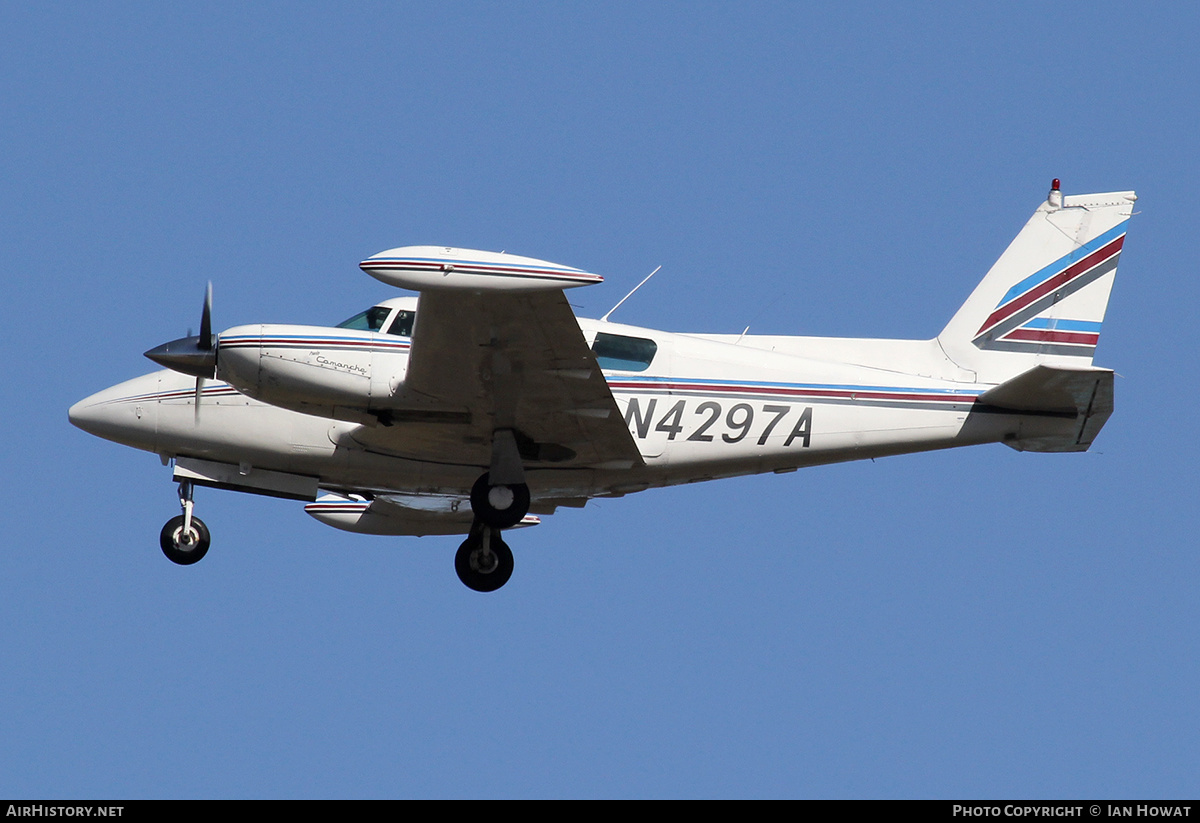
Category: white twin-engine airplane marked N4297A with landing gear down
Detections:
[{"x1": 70, "y1": 180, "x2": 1136, "y2": 591}]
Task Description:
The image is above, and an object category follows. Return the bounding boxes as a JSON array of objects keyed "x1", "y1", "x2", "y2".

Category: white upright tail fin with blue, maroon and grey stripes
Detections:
[{"x1": 937, "y1": 180, "x2": 1138, "y2": 383}]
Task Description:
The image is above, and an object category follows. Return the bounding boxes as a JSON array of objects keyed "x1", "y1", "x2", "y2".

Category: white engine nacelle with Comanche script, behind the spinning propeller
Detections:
[{"x1": 217, "y1": 325, "x2": 410, "y2": 416}]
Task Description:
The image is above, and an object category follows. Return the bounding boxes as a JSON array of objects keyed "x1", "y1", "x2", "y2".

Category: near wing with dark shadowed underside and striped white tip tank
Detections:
[{"x1": 355, "y1": 247, "x2": 642, "y2": 468}]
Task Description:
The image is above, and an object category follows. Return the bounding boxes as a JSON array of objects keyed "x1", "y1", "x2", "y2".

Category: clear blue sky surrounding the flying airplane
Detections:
[{"x1": 0, "y1": 2, "x2": 1200, "y2": 798}]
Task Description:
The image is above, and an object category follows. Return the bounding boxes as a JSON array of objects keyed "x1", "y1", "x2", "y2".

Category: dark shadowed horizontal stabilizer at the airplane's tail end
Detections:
[{"x1": 978, "y1": 365, "x2": 1112, "y2": 451}]
